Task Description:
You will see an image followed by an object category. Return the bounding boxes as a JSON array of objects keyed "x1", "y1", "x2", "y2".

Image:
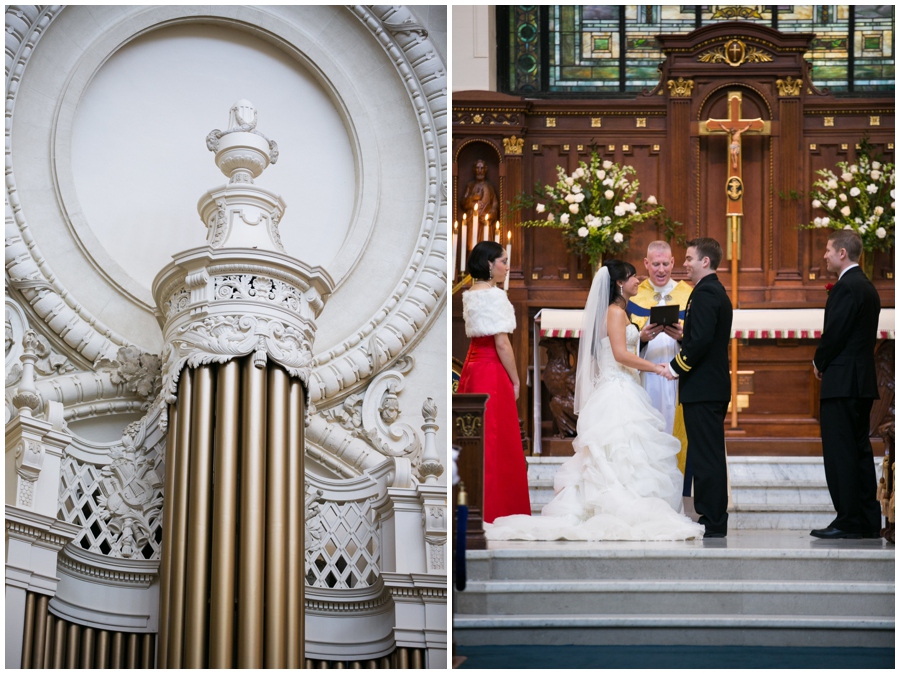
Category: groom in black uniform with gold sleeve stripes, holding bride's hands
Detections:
[{"x1": 669, "y1": 238, "x2": 732, "y2": 538}]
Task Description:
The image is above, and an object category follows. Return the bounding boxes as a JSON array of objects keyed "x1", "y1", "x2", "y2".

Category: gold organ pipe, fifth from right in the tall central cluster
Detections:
[{"x1": 182, "y1": 365, "x2": 213, "y2": 669}]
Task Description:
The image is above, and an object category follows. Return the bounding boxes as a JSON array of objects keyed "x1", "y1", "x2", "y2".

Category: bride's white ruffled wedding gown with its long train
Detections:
[{"x1": 485, "y1": 325, "x2": 704, "y2": 541}]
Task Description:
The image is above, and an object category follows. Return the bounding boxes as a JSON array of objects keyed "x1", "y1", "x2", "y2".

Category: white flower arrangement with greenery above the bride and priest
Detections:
[{"x1": 513, "y1": 152, "x2": 665, "y2": 266}]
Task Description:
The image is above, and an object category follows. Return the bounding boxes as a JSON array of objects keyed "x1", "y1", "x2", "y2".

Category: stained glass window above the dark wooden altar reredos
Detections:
[{"x1": 497, "y1": 5, "x2": 894, "y2": 97}]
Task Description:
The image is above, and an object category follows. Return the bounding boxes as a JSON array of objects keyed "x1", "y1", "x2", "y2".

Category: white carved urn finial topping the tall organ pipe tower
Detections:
[{"x1": 206, "y1": 98, "x2": 278, "y2": 183}]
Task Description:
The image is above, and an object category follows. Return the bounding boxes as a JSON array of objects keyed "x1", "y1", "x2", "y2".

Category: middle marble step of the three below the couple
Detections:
[{"x1": 454, "y1": 579, "x2": 894, "y2": 617}]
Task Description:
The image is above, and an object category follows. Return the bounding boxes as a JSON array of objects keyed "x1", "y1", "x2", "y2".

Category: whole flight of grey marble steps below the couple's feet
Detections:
[{"x1": 453, "y1": 531, "x2": 895, "y2": 648}]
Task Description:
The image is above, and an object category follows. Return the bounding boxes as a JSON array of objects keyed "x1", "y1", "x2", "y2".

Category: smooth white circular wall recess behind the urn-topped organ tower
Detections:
[{"x1": 67, "y1": 24, "x2": 357, "y2": 296}]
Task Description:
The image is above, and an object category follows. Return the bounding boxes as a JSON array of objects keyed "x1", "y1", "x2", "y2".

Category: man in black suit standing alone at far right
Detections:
[{"x1": 811, "y1": 229, "x2": 881, "y2": 538}]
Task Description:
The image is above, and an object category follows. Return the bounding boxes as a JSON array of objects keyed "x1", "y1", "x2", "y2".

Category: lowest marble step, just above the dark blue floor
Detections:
[{"x1": 453, "y1": 613, "x2": 894, "y2": 648}]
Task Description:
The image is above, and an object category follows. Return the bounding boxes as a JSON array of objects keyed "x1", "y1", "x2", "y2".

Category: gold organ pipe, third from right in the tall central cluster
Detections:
[{"x1": 237, "y1": 356, "x2": 266, "y2": 668}]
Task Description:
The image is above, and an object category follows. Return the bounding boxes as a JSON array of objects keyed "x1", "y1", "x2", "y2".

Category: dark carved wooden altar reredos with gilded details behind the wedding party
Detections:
[{"x1": 452, "y1": 22, "x2": 895, "y2": 454}]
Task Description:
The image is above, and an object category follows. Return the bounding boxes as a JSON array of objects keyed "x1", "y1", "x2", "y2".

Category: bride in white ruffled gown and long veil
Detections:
[{"x1": 485, "y1": 260, "x2": 704, "y2": 541}]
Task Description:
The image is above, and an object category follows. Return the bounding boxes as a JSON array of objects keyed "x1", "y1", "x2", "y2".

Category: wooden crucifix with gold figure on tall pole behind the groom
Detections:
[{"x1": 701, "y1": 91, "x2": 771, "y2": 430}]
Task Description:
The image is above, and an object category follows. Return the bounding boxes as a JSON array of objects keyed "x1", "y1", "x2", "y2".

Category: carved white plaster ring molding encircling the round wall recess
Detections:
[{"x1": 6, "y1": 6, "x2": 447, "y2": 414}]
